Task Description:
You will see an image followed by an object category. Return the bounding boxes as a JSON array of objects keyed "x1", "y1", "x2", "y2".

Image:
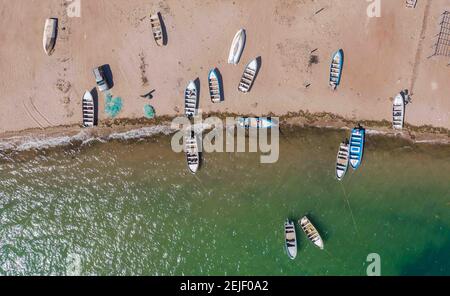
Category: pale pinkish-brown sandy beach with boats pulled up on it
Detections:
[{"x1": 0, "y1": 0, "x2": 450, "y2": 137}]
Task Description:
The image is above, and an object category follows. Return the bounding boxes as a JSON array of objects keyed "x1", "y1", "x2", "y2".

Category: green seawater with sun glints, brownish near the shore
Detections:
[{"x1": 0, "y1": 129, "x2": 450, "y2": 275}]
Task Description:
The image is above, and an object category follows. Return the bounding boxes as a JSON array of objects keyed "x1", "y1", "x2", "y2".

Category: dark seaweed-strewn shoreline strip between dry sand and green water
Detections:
[{"x1": 0, "y1": 111, "x2": 450, "y2": 157}]
